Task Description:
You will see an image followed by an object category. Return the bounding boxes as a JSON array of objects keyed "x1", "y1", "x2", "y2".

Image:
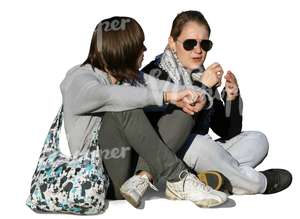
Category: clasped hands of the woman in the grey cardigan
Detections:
[{"x1": 166, "y1": 90, "x2": 206, "y2": 115}]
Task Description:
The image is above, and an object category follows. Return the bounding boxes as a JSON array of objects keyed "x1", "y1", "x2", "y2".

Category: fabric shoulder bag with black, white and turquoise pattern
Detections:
[{"x1": 26, "y1": 106, "x2": 109, "y2": 215}]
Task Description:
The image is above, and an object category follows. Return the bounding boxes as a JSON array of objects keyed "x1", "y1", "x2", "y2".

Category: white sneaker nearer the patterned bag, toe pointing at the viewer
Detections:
[{"x1": 120, "y1": 175, "x2": 158, "y2": 208}]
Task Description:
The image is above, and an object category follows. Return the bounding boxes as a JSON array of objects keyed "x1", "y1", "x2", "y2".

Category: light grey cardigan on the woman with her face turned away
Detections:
[{"x1": 60, "y1": 65, "x2": 212, "y2": 156}]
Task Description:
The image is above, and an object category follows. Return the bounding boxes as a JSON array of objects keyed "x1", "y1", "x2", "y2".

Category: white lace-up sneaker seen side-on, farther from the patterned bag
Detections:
[{"x1": 166, "y1": 171, "x2": 227, "y2": 207}]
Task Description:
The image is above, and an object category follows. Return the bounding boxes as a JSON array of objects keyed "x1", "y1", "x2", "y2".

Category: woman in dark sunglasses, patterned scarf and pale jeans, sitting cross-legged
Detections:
[{"x1": 142, "y1": 11, "x2": 292, "y2": 194}]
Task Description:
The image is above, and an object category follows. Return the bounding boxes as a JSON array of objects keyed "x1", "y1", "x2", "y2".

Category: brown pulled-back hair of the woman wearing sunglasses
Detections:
[{"x1": 170, "y1": 11, "x2": 210, "y2": 40}]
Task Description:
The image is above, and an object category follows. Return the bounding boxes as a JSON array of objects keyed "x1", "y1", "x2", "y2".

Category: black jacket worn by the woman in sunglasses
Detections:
[{"x1": 142, "y1": 59, "x2": 242, "y2": 140}]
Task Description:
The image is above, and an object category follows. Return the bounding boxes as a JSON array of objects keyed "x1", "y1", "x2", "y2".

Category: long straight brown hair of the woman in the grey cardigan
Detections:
[{"x1": 82, "y1": 17, "x2": 145, "y2": 81}]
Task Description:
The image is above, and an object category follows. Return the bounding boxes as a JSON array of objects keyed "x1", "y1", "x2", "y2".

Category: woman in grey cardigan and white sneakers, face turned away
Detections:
[{"x1": 61, "y1": 17, "x2": 227, "y2": 207}]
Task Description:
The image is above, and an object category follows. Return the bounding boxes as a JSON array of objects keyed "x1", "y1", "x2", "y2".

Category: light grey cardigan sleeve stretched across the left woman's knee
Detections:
[{"x1": 65, "y1": 75, "x2": 163, "y2": 114}]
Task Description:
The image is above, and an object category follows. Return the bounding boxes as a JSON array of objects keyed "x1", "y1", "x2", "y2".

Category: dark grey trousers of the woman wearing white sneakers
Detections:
[{"x1": 99, "y1": 109, "x2": 189, "y2": 199}]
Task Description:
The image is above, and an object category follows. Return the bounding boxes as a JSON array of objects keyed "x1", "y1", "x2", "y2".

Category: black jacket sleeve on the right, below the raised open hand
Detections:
[{"x1": 210, "y1": 90, "x2": 243, "y2": 140}]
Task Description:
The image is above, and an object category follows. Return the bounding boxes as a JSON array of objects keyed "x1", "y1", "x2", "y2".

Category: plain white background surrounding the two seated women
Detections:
[{"x1": 0, "y1": 0, "x2": 300, "y2": 219}]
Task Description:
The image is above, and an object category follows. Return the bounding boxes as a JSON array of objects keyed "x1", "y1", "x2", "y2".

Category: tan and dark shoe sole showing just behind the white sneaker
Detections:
[{"x1": 197, "y1": 171, "x2": 223, "y2": 190}]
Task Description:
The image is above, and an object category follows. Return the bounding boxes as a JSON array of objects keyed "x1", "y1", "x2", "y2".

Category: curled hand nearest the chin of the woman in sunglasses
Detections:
[{"x1": 200, "y1": 63, "x2": 224, "y2": 88}]
